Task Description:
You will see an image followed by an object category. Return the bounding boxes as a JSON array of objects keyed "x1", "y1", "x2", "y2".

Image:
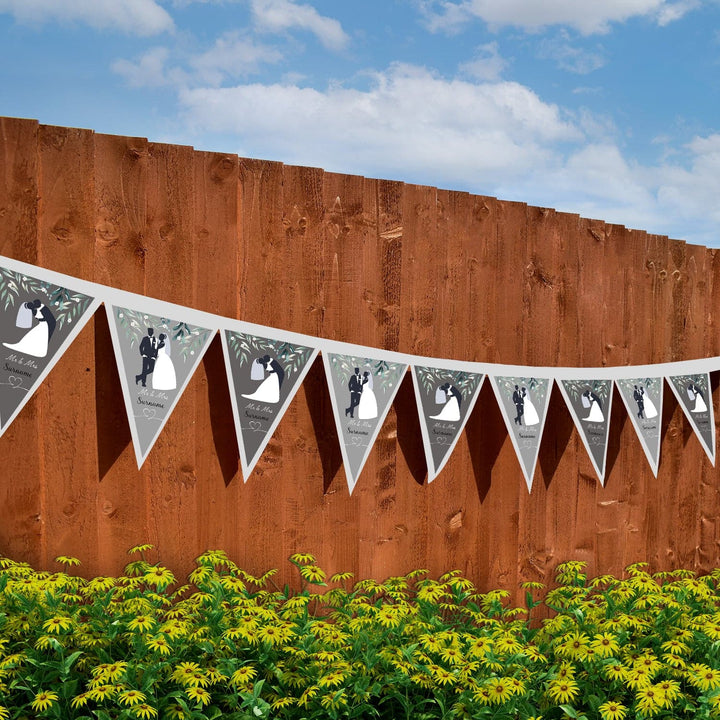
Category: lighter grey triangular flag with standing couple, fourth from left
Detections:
[{"x1": 323, "y1": 353, "x2": 407, "y2": 494}]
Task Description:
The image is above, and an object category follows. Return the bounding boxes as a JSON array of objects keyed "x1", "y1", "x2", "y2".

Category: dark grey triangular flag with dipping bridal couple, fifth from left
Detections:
[{"x1": 412, "y1": 365, "x2": 485, "y2": 483}]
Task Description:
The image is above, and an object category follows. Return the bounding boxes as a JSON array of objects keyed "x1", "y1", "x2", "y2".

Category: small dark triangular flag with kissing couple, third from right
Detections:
[{"x1": 558, "y1": 378, "x2": 613, "y2": 485}]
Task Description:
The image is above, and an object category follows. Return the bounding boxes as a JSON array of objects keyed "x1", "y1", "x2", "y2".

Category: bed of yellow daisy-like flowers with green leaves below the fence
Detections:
[{"x1": 0, "y1": 546, "x2": 720, "y2": 720}]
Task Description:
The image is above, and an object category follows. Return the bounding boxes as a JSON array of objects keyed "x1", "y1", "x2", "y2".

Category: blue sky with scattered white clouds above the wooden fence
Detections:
[{"x1": 0, "y1": 0, "x2": 720, "y2": 247}]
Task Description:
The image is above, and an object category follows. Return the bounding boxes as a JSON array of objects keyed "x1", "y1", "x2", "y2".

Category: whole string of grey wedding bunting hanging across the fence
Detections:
[{"x1": 0, "y1": 257, "x2": 720, "y2": 492}]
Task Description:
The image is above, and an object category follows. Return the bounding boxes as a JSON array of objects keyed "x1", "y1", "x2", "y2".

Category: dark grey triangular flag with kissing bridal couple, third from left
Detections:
[{"x1": 222, "y1": 330, "x2": 318, "y2": 482}]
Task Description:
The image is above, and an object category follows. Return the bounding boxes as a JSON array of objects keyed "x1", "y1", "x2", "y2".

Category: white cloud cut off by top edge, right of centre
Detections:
[{"x1": 420, "y1": 0, "x2": 699, "y2": 35}]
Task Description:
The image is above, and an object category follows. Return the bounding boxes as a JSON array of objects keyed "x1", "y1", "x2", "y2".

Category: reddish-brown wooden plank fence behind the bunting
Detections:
[{"x1": 0, "y1": 119, "x2": 720, "y2": 590}]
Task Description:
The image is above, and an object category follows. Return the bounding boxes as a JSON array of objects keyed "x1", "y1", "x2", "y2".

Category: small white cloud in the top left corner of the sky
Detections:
[{"x1": 0, "y1": 0, "x2": 174, "y2": 35}]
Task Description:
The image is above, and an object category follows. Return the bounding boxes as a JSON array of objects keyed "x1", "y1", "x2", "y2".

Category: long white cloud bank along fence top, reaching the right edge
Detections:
[{"x1": 173, "y1": 65, "x2": 720, "y2": 245}]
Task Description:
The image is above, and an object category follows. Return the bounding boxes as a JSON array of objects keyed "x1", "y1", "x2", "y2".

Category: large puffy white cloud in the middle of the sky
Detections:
[{"x1": 180, "y1": 65, "x2": 582, "y2": 185}]
